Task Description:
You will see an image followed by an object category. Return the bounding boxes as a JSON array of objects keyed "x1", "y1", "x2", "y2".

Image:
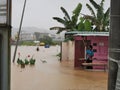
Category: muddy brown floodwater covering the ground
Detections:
[{"x1": 11, "y1": 46, "x2": 108, "y2": 90}]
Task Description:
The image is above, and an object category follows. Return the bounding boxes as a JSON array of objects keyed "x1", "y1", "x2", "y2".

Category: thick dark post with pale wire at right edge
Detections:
[{"x1": 108, "y1": 0, "x2": 120, "y2": 90}]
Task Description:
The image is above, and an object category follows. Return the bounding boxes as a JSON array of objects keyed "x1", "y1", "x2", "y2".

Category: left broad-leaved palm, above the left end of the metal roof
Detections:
[{"x1": 50, "y1": 3, "x2": 82, "y2": 33}]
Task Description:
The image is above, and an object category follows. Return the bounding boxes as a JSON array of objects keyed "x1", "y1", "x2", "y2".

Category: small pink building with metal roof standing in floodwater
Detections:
[{"x1": 62, "y1": 31, "x2": 109, "y2": 68}]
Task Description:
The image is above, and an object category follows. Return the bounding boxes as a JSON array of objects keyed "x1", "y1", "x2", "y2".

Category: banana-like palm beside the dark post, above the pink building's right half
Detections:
[{"x1": 84, "y1": 0, "x2": 110, "y2": 31}]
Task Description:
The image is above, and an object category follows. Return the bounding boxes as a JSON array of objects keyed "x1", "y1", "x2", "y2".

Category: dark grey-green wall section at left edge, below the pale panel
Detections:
[{"x1": 0, "y1": 28, "x2": 11, "y2": 90}]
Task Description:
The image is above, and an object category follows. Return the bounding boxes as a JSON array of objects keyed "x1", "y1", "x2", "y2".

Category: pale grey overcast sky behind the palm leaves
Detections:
[{"x1": 12, "y1": 0, "x2": 110, "y2": 29}]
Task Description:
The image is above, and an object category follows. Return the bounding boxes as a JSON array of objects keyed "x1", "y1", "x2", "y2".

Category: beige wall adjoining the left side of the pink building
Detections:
[{"x1": 62, "y1": 41, "x2": 75, "y2": 61}]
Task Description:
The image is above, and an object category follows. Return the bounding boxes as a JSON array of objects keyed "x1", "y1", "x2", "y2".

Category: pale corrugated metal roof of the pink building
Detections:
[{"x1": 65, "y1": 31, "x2": 109, "y2": 36}]
